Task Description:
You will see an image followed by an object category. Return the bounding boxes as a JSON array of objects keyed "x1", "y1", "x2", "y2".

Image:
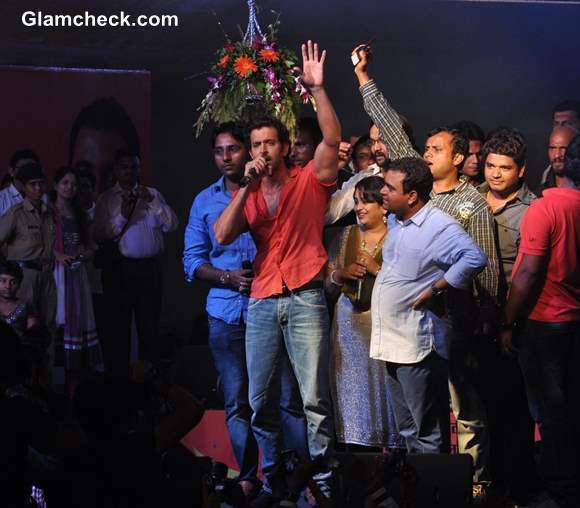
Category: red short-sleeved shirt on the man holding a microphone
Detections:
[{"x1": 244, "y1": 161, "x2": 335, "y2": 298}]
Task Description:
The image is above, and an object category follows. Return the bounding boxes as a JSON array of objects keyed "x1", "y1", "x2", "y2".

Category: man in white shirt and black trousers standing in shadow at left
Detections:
[{"x1": 94, "y1": 149, "x2": 177, "y2": 373}]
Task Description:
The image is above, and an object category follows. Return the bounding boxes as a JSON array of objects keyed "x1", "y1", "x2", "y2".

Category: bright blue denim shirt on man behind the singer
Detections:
[{"x1": 183, "y1": 176, "x2": 256, "y2": 324}]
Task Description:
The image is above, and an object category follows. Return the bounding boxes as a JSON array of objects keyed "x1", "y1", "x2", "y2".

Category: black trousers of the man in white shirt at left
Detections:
[{"x1": 101, "y1": 257, "x2": 163, "y2": 375}]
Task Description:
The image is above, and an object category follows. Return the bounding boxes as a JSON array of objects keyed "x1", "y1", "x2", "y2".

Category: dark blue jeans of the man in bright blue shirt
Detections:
[{"x1": 209, "y1": 316, "x2": 308, "y2": 482}]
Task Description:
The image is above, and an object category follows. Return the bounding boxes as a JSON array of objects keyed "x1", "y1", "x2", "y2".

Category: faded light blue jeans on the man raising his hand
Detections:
[{"x1": 246, "y1": 289, "x2": 333, "y2": 487}]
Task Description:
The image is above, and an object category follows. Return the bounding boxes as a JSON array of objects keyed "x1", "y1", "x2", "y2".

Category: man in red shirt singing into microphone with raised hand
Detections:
[{"x1": 214, "y1": 41, "x2": 341, "y2": 506}]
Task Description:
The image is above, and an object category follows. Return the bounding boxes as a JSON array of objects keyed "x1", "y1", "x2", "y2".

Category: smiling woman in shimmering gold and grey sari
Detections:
[{"x1": 325, "y1": 176, "x2": 405, "y2": 448}]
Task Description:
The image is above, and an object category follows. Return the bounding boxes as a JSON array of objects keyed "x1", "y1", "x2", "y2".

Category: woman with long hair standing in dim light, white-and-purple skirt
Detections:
[{"x1": 51, "y1": 167, "x2": 103, "y2": 395}]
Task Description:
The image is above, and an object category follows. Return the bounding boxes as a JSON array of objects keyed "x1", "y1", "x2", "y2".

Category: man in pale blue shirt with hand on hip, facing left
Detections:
[{"x1": 370, "y1": 157, "x2": 487, "y2": 453}]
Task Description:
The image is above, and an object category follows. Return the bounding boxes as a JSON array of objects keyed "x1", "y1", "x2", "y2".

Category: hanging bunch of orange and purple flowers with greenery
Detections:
[{"x1": 195, "y1": 0, "x2": 314, "y2": 139}]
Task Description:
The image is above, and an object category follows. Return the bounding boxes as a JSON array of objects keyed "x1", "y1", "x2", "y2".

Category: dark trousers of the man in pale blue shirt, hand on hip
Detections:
[{"x1": 387, "y1": 351, "x2": 450, "y2": 453}]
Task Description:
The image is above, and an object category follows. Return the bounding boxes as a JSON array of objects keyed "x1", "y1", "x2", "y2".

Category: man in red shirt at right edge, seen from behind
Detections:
[{"x1": 502, "y1": 135, "x2": 580, "y2": 507}]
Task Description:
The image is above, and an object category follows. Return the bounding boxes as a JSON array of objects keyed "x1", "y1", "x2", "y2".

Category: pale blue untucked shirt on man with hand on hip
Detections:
[{"x1": 370, "y1": 204, "x2": 487, "y2": 364}]
